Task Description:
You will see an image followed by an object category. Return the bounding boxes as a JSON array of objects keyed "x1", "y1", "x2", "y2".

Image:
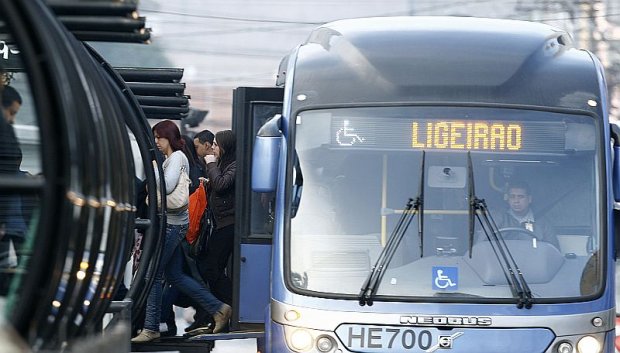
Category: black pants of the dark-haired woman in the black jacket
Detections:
[{"x1": 198, "y1": 224, "x2": 235, "y2": 305}]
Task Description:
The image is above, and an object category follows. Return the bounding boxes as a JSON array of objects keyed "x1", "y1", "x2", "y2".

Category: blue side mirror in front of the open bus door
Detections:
[{"x1": 252, "y1": 114, "x2": 284, "y2": 192}]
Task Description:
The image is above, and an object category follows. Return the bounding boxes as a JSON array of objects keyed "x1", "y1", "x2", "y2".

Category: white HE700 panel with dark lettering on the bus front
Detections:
[{"x1": 336, "y1": 324, "x2": 462, "y2": 352}]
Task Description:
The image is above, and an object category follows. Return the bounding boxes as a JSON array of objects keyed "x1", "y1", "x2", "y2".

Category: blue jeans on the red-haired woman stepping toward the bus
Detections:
[{"x1": 144, "y1": 224, "x2": 223, "y2": 331}]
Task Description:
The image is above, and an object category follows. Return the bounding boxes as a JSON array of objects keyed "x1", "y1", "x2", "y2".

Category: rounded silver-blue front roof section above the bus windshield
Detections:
[{"x1": 288, "y1": 17, "x2": 601, "y2": 110}]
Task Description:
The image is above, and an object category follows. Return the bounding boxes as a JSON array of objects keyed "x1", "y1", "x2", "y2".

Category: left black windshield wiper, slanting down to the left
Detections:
[{"x1": 359, "y1": 151, "x2": 425, "y2": 306}]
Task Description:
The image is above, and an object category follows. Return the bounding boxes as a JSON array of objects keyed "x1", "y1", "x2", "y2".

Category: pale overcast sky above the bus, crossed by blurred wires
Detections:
[{"x1": 95, "y1": 0, "x2": 616, "y2": 130}]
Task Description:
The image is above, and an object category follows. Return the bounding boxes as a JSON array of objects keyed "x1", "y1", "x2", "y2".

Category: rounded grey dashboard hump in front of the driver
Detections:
[{"x1": 463, "y1": 240, "x2": 564, "y2": 285}]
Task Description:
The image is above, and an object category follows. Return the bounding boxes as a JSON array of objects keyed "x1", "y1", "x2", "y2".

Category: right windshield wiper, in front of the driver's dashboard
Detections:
[{"x1": 467, "y1": 152, "x2": 532, "y2": 309}]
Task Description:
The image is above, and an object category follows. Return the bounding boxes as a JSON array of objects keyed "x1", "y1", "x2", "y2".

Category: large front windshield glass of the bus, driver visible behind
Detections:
[{"x1": 289, "y1": 107, "x2": 602, "y2": 300}]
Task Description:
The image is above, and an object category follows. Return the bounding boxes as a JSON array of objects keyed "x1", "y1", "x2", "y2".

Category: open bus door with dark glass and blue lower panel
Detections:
[{"x1": 231, "y1": 87, "x2": 284, "y2": 330}]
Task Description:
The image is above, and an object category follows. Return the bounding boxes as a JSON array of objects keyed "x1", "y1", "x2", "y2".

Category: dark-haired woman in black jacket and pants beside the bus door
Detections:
[{"x1": 200, "y1": 130, "x2": 237, "y2": 304}]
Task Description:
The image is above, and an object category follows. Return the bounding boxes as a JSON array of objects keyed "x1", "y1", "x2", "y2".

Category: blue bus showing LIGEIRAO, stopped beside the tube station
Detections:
[{"x1": 233, "y1": 17, "x2": 620, "y2": 353}]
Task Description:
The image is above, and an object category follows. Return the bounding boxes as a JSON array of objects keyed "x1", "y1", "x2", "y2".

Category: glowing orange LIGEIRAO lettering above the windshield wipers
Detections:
[{"x1": 411, "y1": 121, "x2": 523, "y2": 151}]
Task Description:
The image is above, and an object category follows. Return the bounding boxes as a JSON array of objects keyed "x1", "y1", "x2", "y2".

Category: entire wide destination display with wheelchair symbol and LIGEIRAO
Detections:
[{"x1": 331, "y1": 117, "x2": 567, "y2": 153}]
